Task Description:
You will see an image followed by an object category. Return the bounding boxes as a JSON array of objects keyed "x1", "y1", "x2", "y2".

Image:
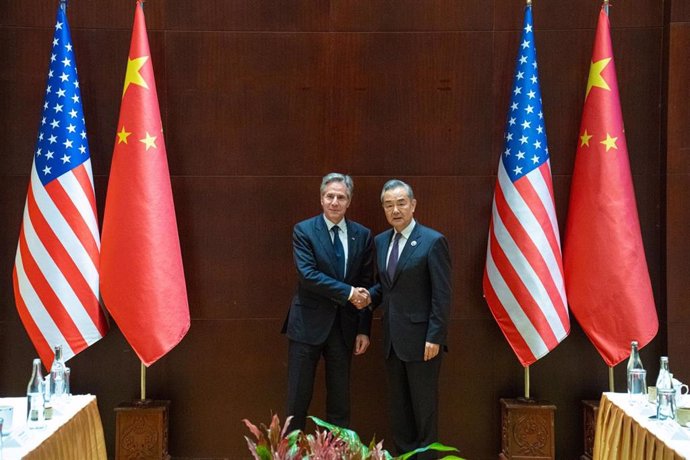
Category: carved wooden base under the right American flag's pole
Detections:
[{"x1": 499, "y1": 399, "x2": 556, "y2": 460}]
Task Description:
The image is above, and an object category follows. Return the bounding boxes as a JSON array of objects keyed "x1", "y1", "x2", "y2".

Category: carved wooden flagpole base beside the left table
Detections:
[{"x1": 115, "y1": 399, "x2": 170, "y2": 460}]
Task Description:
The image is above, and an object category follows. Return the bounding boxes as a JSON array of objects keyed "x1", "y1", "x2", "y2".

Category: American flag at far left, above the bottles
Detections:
[{"x1": 12, "y1": 3, "x2": 108, "y2": 367}]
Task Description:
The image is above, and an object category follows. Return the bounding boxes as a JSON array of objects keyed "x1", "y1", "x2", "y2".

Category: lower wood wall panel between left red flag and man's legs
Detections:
[{"x1": 163, "y1": 319, "x2": 287, "y2": 458}]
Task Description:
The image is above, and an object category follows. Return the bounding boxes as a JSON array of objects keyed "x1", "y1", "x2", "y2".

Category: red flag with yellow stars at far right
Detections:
[{"x1": 563, "y1": 8, "x2": 659, "y2": 366}]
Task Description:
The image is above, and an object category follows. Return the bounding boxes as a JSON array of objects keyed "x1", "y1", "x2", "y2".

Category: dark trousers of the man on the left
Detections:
[{"x1": 287, "y1": 319, "x2": 352, "y2": 431}]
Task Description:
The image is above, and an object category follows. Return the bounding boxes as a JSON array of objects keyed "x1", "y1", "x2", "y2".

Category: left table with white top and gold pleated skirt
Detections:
[{"x1": 0, "y1": 395, "x2": 108, "y2": 460}]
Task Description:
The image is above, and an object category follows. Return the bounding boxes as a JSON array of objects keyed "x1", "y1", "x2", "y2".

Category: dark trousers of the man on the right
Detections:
[{"x1": 386, "y1": 349, "x2": 442, "y2": 459}]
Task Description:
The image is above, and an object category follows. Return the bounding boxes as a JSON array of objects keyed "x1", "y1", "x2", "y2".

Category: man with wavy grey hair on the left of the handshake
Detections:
[{"x1": 283, "y1": 173, "x2": 373, "y2": 430}]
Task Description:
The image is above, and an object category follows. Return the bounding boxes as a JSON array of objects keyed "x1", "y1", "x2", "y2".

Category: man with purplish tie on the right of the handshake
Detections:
[{"x1": 370, "y1": 179, "x2": 451, "y2": 458}]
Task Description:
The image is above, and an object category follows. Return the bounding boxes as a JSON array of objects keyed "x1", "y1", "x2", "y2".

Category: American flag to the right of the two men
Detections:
[{"x1": 483, "y1": 5, "x2": 570, "y2": 366}]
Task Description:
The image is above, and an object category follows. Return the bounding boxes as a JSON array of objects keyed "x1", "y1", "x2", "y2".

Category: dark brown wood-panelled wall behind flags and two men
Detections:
[{"x1": 0, "y1": 0, "x2": 676, "y2": 459}]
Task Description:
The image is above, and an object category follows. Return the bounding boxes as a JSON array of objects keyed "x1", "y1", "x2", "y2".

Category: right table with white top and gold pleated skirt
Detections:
[{"x1": 594, "y1": 393, "x2": 690, "y2": 460}]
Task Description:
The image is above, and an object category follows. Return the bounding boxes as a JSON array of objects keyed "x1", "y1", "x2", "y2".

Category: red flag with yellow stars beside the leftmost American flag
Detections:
[{"x1": 100, "y1": 2, "x2": 189, "y2": 366}]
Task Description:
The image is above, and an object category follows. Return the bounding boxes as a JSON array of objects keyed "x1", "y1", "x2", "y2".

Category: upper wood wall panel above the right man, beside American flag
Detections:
[{"x1": 325, "y1": 32, "x2": 493, "y2": 176}]
